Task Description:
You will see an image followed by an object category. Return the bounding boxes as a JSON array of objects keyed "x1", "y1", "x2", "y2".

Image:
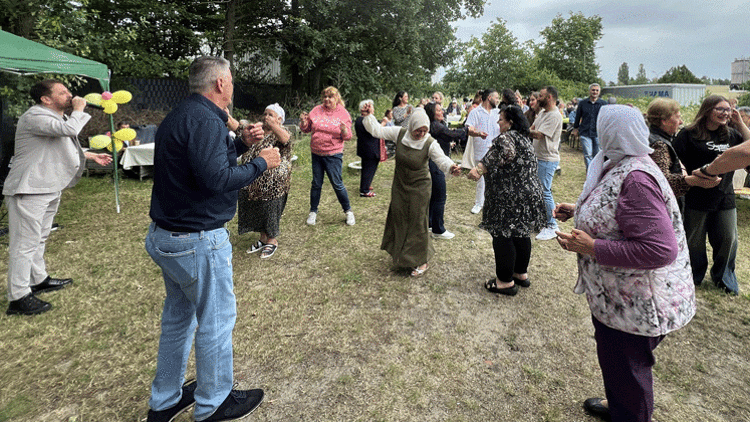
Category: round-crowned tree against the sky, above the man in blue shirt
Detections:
[{"x1": 537, "y1": 12, "x2": 602, "y2": 83}]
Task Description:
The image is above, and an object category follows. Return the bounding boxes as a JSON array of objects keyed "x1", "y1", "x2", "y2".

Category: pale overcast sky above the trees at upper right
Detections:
[{"x1": 454, "y1": 0, "x2": 750, "y2": 82}]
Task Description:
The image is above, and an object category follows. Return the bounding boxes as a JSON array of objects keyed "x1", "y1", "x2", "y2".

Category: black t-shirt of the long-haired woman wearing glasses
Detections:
[{"x1": 672, "y1": 128, "x2": 743, "y2": 211}]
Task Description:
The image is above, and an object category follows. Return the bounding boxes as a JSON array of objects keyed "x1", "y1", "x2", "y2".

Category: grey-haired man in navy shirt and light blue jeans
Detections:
[{"x1": 146, "y1": 57, "x2": 279, "y2": 422}]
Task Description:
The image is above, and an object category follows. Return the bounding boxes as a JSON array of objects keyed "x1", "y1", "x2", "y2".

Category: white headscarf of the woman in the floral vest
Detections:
[{"x1": 580, "y1": 105, "x2": 654, "y2": 200}]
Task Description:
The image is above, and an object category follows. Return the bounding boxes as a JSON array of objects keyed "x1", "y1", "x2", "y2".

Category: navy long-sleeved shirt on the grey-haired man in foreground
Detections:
[{"x1": 150, "y1": 94, "x2": 266, "y2": 232}]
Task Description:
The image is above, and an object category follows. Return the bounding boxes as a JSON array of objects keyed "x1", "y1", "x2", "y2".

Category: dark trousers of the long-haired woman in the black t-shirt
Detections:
[{"x1": 684, "y1": 208, "x2": 740, "y2": 293}]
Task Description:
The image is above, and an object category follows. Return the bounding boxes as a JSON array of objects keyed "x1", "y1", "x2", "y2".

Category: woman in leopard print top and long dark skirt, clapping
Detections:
[{"x1": 237, "y1": 104, "x2": 292, "y2": 258}]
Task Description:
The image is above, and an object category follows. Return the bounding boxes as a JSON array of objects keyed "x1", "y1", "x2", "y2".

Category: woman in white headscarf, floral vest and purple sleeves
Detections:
[{"x1": 554, "y1": 105, "x2": 696, "y2": 422}]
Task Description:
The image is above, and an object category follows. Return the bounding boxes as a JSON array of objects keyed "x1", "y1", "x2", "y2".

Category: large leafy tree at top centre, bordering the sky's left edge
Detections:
[{"x1": 234, "y1": 0, "x2": 484, "y2": 97}]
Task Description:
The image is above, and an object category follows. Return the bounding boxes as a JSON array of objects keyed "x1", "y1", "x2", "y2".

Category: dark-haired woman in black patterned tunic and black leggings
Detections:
[{"x1": 468, "y1": 105, "x2": 547, "y2": 296}]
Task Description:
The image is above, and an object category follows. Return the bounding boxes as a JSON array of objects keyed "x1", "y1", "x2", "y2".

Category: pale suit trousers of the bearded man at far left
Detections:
[{"x1": 5, "y1": 192, "x2": 60, "y2": 300}]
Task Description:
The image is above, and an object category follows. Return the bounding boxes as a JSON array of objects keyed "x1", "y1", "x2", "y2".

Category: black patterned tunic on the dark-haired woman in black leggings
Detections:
[{"x1": 479, "y1": 130, "x2": 547, "y2": 238}]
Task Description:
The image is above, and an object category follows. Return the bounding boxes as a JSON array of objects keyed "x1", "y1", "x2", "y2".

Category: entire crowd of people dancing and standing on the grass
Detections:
[{"x1": 3, "y1": 57, "x2": 750, "y2": 422}]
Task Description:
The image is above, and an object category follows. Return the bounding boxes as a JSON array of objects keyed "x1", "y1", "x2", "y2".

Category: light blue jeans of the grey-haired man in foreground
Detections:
[{"x1": 146, "y1": 223, "x2": 237, "y2": 421}]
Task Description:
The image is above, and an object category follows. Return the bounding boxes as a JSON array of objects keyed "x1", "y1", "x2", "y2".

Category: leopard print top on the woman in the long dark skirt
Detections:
[{"x1": 240, "y1": 132, "x2": 294, "y2": 201}]
